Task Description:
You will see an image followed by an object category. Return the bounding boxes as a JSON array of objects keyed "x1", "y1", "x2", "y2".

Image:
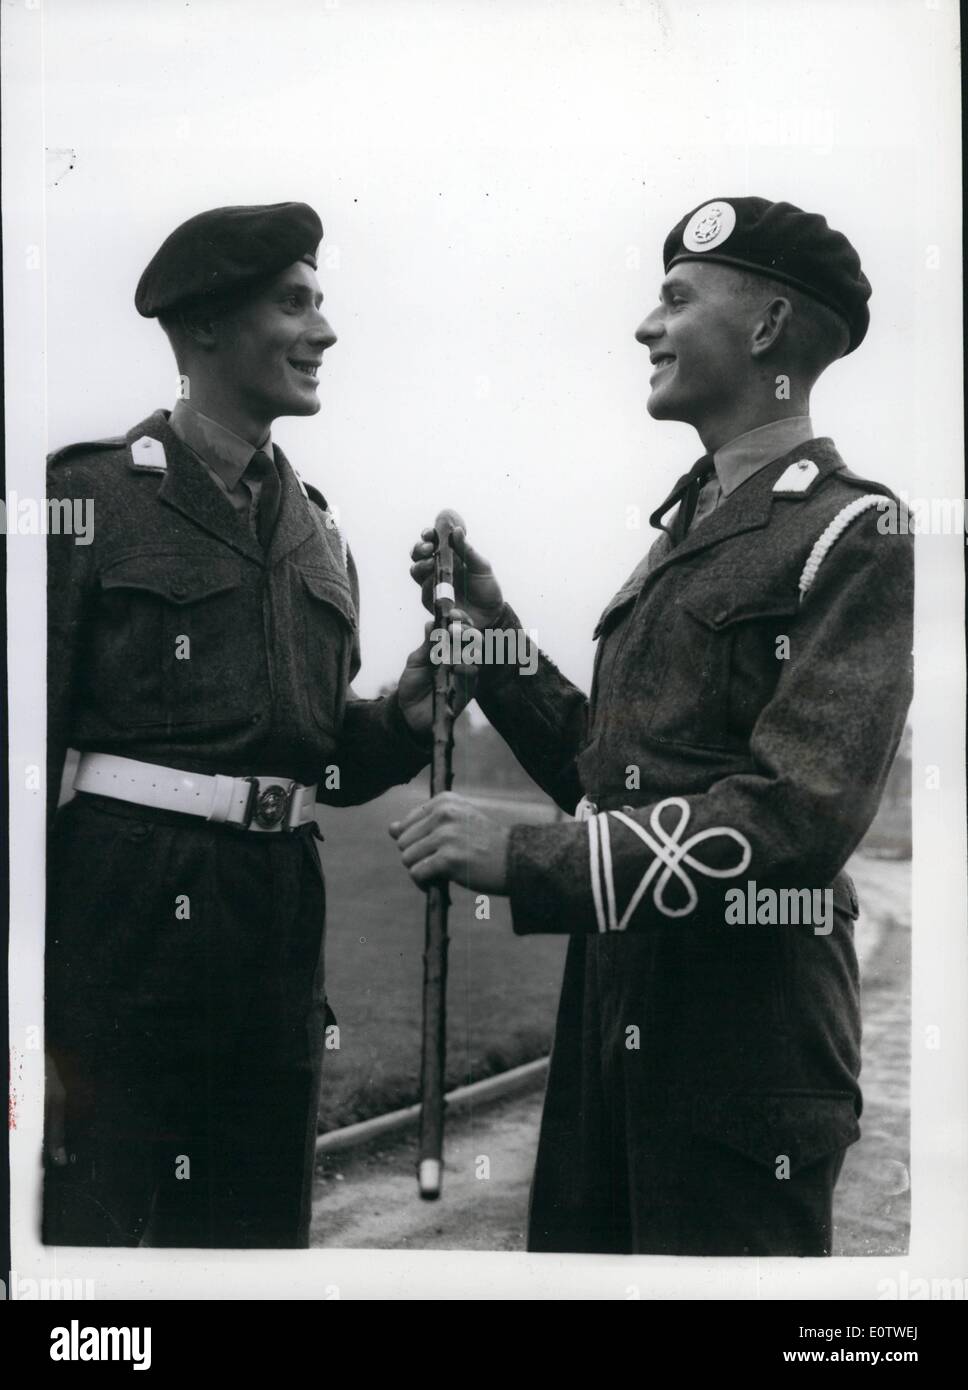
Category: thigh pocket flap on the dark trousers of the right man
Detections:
[{"x1": 693, "y1": 1091, "x2": 861, "y2": 1172}]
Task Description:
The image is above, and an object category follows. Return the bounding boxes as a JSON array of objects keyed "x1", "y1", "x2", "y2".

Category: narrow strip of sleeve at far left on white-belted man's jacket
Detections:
[{"x1": 47, "y1": 464, "x2": 97, "y2": 830}]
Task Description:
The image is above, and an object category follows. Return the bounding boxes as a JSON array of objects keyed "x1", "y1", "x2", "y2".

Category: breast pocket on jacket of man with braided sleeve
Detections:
[{"x1": 650, "y1": 595, "x2": 797, "y2": 751}]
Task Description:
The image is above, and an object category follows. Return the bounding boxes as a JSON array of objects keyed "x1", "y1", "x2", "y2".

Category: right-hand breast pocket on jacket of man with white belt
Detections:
[{"x1": 295, "y1": 570, "x2": 357, "y2": 734}]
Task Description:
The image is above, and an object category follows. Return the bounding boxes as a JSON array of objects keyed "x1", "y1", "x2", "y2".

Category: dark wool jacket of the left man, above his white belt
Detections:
[{"x1": 47, "y1": 411, "x2": 428, "y2": 815}]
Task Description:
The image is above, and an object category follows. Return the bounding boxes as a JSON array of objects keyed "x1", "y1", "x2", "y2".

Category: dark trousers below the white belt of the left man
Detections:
[{"x1": 43, "y1": 796, "x2": 325, "y2": 1247}]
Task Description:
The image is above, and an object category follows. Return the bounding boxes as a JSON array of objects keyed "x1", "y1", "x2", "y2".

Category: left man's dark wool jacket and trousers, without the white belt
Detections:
[{"x1": 43, "y1": 411, "x2": 428, "y2": 1247}]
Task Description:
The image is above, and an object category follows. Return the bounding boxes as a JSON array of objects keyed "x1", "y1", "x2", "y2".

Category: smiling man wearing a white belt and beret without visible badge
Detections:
[{"x1": 43, "y1": 203, "x2": 450, "y2": 1247}]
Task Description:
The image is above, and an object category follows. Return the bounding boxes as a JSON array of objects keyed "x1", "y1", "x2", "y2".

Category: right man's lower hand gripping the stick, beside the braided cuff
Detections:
[{"x1": 389, "y1": 791, "x2": 509, "y2": 892}]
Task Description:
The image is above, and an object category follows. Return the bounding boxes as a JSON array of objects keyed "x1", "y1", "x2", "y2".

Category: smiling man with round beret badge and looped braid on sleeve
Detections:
[{"x1": 391, "y1": 197, "x2": 912, "y2": 1255}]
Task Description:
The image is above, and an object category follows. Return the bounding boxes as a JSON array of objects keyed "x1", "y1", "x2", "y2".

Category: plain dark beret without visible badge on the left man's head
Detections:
[{"x1": 135, "y1": 203, "x2": 323, "y2": 318}]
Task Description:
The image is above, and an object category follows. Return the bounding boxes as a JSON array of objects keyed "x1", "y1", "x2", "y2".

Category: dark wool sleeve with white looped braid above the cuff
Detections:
[{"x1": 509, "y1": 513, "x2": 914, "y2": 933}]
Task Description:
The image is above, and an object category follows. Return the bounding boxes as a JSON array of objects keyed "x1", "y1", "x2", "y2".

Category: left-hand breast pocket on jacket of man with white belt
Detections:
[{"x1": 95, "y1": 552, "x2": 268, "y2": 730}]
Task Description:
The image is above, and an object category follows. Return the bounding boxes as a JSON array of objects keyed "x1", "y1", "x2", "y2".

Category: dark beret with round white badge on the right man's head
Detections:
[{"x1": 662, "y1": 197, "x2": 871, "y2": 352}]
